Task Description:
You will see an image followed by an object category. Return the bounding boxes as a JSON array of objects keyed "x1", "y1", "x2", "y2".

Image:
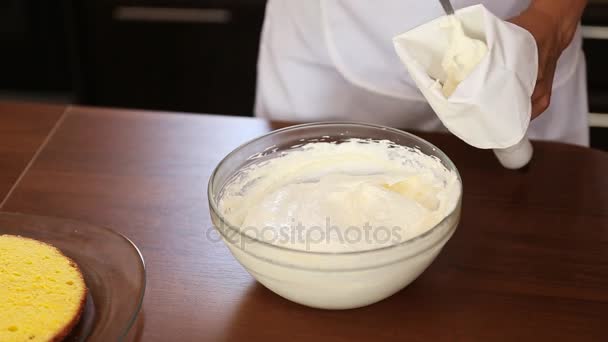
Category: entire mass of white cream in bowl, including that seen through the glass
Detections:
[{"x1": 210, "y1": 128, "x2": 461, "y2": 309}]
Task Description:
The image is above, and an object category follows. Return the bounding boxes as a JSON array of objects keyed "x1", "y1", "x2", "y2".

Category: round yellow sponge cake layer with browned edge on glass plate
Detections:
[{"x1": 0, "y1": 235, "x2": 86, "y2": 342}]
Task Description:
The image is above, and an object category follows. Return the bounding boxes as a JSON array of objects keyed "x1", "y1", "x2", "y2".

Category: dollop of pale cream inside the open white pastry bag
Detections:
[{"x1": 441, "y1": 15, "x2": 488, "y2": 97}]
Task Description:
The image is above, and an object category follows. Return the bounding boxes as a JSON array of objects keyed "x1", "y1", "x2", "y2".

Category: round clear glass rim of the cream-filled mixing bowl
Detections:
[{"x1": 207, "y1": 121, "x2": 464, "y2": 256}]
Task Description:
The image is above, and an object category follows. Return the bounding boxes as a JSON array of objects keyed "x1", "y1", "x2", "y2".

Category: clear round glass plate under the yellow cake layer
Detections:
[{"x1": 0, "y1": 212, "x2": 146, "y2": 342}]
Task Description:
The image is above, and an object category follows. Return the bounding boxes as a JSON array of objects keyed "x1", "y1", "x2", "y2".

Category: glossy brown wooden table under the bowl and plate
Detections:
[{"x1": 0, "y1": 103, "x2": 608, "y2": 341}]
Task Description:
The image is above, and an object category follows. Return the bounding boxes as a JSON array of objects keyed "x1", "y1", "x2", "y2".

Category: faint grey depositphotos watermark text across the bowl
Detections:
[{"x1": 205, "y1": 217, "x2": 405, "y2": 250}]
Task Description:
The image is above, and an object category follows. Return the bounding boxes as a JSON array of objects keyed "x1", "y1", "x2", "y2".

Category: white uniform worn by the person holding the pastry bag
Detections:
[{"x1": 255, "y1": 0, "x2": 589, "y2": 145}]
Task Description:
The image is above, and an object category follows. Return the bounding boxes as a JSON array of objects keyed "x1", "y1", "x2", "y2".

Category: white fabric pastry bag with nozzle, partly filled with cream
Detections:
[{"x1": 393, "y1": 5, "x2": 537, "y2": 169}]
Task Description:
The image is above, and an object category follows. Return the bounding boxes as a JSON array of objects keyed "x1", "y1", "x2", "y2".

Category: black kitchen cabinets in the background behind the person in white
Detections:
[{"x1": 0, "y1": 0, "x2": 608, "y2": 150}]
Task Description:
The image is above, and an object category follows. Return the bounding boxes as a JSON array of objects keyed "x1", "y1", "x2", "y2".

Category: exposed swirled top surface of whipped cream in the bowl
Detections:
[{"x1": 219, "y1": 139, "x2": 461, "y2": 252}]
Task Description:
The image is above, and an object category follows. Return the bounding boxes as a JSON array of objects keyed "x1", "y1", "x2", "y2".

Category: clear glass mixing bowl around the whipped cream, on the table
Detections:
[{"x1": 208, "y1": 122, "x2": 462, "y2": 309}]
